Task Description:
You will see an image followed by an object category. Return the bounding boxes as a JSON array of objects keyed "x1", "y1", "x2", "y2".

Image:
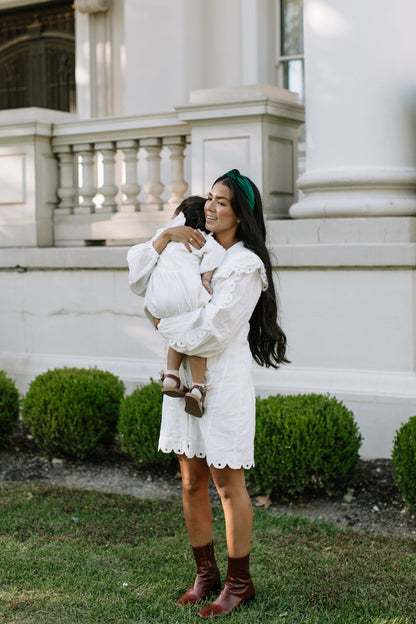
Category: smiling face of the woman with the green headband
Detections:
[{"x1": 205, "y1": 182, "x2": 239, "y2": 249}]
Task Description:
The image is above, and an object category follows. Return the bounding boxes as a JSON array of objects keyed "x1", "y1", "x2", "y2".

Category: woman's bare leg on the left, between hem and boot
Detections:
[{"x1": 178, "y1": 455, "x2": 212, "y2": 547}]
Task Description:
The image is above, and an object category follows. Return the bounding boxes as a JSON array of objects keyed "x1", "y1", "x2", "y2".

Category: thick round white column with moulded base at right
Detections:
[{"x1": 290, "y1": 0, "x2": 416, "y2": 218}]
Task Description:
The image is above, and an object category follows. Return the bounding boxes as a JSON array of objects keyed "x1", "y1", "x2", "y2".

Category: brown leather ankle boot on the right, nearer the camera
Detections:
[{"x1": 198, "y1": 554, "x2": 254, "y2": 620}]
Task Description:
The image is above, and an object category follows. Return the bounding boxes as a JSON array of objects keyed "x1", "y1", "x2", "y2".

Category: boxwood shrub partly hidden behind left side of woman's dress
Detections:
[{"x1": 118, "y1": 380, "x2": 177, "y2": 470}]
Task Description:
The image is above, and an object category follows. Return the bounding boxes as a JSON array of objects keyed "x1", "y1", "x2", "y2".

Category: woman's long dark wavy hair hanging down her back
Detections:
[{"x1": 214, "y1": 174, "x2": 289, "y2": 368}]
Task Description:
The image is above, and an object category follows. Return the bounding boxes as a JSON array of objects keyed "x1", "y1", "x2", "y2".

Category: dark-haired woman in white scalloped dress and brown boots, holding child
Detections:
[{"x1": 130, "y1": 169, "x2": 287, "y2": 619}]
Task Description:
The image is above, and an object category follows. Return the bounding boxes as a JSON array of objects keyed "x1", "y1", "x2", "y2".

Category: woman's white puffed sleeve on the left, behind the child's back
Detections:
[{"x1": 127, "y1": 213, "x2": 185, "y2": 297}]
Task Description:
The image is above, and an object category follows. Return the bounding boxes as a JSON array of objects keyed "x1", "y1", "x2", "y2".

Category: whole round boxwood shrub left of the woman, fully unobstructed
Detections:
[{"x1": 23, "y1": 367, "x2": 125, "y2": 459}]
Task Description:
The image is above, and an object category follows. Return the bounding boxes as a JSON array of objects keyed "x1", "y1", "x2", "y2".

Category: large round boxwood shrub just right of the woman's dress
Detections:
[{"x1": 246, "y1": 394, "x2": 362, "y2": 494}]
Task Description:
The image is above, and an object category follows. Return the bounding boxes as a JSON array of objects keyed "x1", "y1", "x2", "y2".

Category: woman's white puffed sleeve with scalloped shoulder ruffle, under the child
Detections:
[{"x1": 158, "y1": 246, "x2": 267, "y2": 357}]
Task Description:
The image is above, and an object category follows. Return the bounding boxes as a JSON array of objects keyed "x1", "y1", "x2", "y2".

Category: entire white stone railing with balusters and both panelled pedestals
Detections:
[{"x1": 0, "y1": 85, "x2": 304, "y2": 247}]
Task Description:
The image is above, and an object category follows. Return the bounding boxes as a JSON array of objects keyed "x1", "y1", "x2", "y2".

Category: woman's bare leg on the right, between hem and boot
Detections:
[{"x1": 210, "y1": 466, "x2": 253, "y2": 558}]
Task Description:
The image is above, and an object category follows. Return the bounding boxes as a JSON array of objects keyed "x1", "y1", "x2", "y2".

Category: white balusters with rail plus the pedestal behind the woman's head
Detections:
[{"x1": 51, "y1": 85, "x2": 304, "y2": 246}]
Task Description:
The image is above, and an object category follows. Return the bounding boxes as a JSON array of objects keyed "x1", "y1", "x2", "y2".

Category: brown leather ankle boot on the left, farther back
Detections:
[{"x1": 175, "y1": 542, "x2": 221, "y2": 607}]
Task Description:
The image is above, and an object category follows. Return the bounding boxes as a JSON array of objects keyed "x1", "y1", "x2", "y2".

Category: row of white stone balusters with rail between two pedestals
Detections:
[{"x1": 52, "y1": 114, "x2": 190, "y2": 246}]
